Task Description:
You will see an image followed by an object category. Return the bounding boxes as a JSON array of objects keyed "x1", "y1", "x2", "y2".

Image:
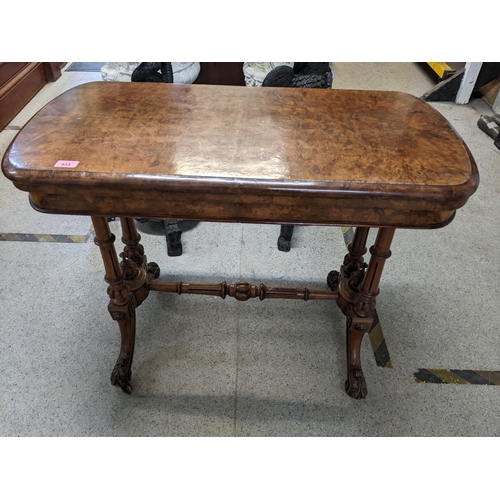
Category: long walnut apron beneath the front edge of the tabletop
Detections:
[{"x1": 26, "y1": 186, "x2": 455, "y2": 229}]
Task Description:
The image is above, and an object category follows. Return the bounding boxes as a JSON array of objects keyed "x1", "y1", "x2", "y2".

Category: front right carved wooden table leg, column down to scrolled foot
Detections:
[{"x1": 343, "y1": 228, "x2": 395, "y2": 399}]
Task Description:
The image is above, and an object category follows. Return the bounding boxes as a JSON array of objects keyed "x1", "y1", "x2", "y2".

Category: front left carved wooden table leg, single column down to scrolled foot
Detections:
[{"x1": 92, "y1": 217, "x2": 137, "y2": 394}]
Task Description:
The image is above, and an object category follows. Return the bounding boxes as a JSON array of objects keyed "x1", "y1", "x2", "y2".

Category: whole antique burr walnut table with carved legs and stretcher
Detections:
[{"x1": 2, "y1": 82, "x2": 478, "y2": 398}]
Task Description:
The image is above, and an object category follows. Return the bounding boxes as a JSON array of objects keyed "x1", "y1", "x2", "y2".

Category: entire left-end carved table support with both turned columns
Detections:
[{"x1": 92, "y1": 217, "x2": 159, "y2": 394}]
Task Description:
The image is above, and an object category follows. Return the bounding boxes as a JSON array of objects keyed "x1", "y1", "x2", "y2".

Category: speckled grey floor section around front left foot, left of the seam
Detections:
[{"x1": 0, "y1": 242, "x2": 236, "y2": 436}]
